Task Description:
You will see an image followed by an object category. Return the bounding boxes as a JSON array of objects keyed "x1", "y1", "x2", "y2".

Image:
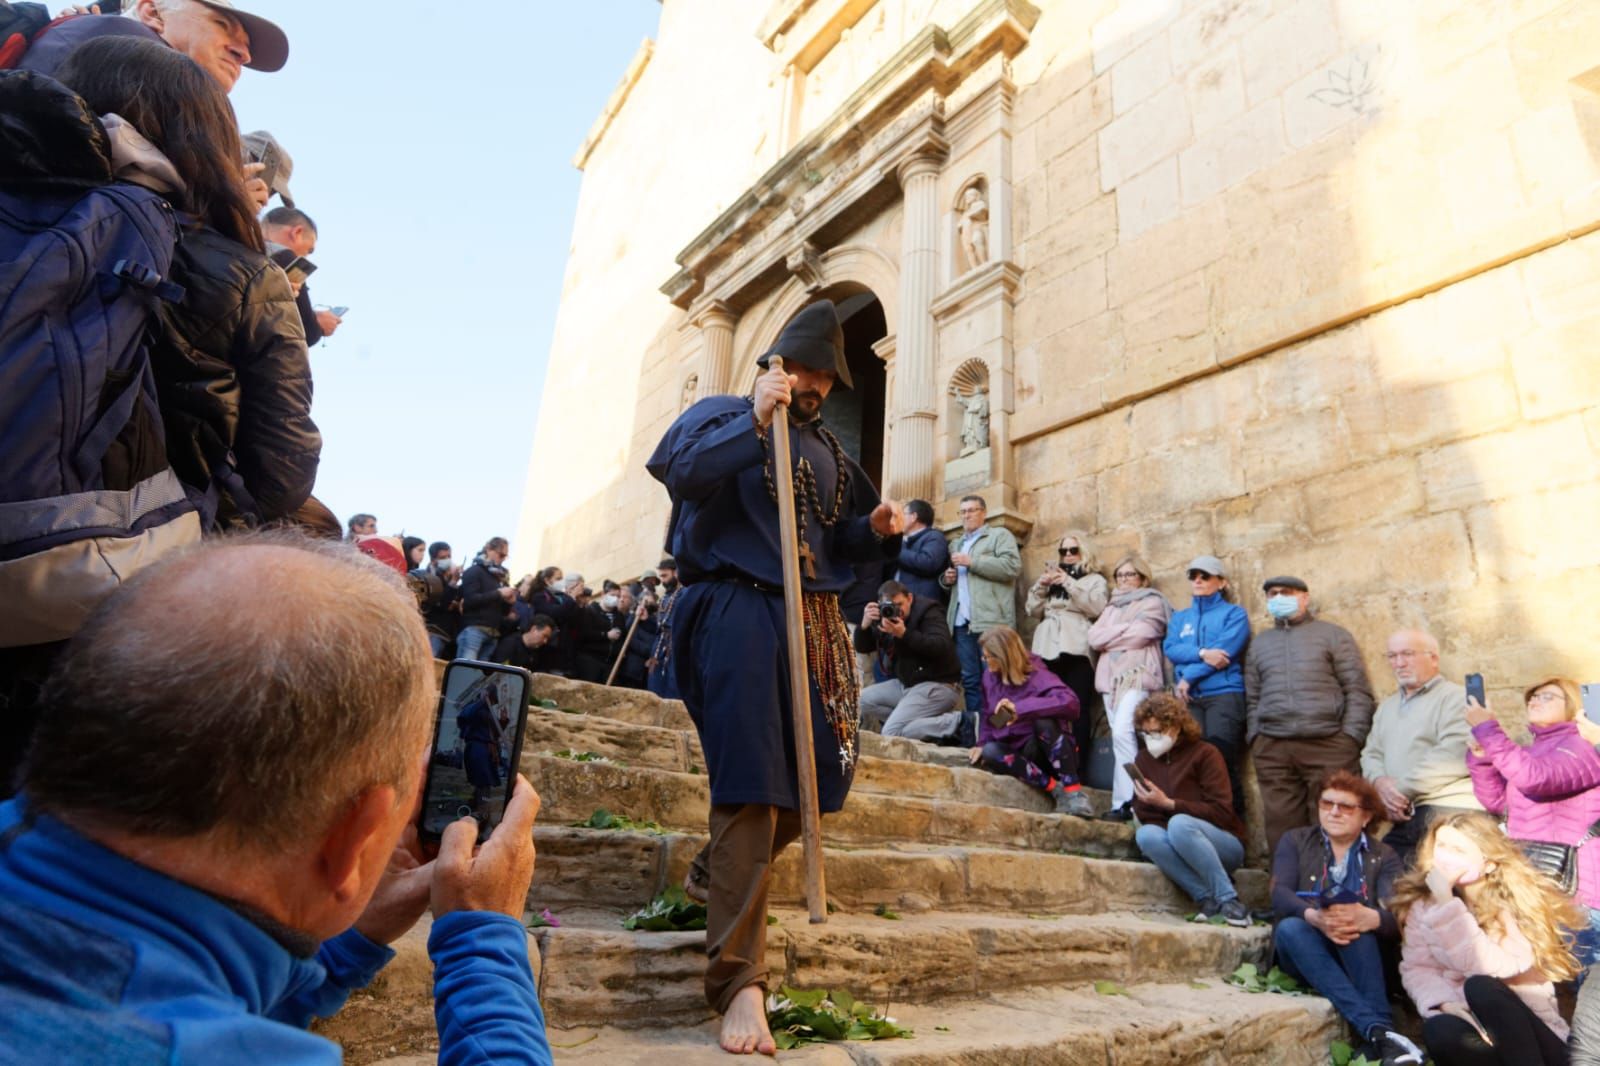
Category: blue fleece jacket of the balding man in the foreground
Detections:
[{"x1": 0, "y1": 799, "x2": 550, "y2": 1066}]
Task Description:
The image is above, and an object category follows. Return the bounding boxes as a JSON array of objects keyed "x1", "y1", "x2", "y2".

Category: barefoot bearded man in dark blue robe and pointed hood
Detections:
[{"x1": 648, "y1": 299, "x2": 901, "y2": 1055}]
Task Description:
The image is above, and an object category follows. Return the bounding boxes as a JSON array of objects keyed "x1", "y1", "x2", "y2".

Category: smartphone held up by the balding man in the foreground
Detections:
[{"x1": 418, "y1": 661, "x2": 530, "y2": 844}]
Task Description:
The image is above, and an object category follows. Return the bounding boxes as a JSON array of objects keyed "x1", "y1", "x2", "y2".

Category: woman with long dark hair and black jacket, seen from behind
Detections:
[{"x1": 58, "y1": 37, "x2": 324, "y2": 536}]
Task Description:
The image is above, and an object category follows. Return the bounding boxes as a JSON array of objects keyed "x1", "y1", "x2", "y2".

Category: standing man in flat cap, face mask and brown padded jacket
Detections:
[{"x1": 1245, "y1": 575, "x2": 1373, "y2": 855}]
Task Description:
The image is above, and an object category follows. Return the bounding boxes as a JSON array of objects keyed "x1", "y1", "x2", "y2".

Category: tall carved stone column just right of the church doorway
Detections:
[{"x1": 886, "y1": 154, "x2": 942, "y2": 499}]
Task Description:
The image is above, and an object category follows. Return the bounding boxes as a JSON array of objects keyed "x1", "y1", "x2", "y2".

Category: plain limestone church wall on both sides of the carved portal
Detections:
[{"x1": 514, "y1": 0, "x2": 1600, "y2": 688}]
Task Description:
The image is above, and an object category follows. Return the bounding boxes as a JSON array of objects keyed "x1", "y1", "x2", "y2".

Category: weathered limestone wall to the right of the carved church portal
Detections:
[{"x1": 1013, "y1": 0, "x2": 1600, "y2": 688}]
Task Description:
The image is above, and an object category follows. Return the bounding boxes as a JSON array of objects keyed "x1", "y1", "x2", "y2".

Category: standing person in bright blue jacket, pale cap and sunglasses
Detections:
[{"x1": 1158, "y1": 555, "x2": 1250, "y2": 821}]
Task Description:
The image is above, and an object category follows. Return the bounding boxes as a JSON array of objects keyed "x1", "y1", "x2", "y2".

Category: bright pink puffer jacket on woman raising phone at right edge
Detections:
[{"x1": 1467, "y1": 722, "x2": 1600, "y2": 909}]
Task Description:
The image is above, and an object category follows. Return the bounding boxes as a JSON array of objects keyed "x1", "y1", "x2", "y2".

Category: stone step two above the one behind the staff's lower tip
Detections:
[{"x1": 523, "y1": 709, "x2": 1110, "y2": 813}]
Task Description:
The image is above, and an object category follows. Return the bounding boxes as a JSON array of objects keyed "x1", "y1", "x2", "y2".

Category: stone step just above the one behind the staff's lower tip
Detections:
[{"x1": 522, "y1": 751, "x2": 1139, "y2": 860}]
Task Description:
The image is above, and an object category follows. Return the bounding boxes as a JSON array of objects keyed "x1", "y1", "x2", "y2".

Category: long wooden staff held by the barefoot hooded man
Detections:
[{"x1": 768, "y1": 355, "x2": 827, "y2": 925}]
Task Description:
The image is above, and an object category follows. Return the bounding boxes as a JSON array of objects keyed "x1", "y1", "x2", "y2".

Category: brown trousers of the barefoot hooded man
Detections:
[{"x1": 690, "y1": 804, "x2": 800, "y2": 1015}]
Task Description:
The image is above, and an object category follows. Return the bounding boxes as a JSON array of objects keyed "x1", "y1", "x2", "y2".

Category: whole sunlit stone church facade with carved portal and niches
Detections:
[{"x1": 512, "y1": 0, "x2": 1600, "y2": 691}]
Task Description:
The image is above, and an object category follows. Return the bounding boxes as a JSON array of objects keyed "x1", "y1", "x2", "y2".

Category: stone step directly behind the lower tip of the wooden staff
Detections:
[{"x1": 528, "y1": 826, "x2": 1267, "y2": 914}]
